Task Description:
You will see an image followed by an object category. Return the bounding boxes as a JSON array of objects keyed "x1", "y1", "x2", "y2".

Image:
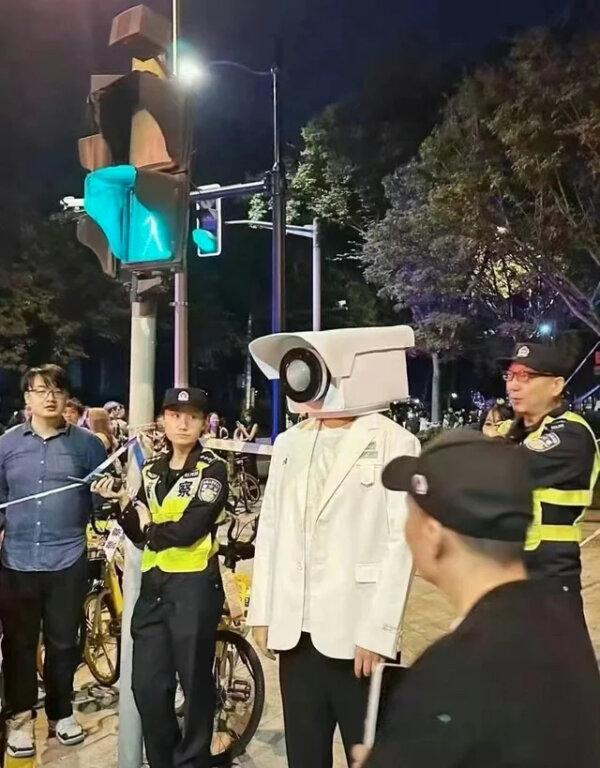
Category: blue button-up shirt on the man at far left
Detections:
[{"x1": 0, "y1": 422, "x2": 106, "y2": 571}]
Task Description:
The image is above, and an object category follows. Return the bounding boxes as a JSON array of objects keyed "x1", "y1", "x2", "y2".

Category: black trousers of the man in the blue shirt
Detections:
[{"x1": 0, "y1": 553, "x2": 88, "y2": 720}]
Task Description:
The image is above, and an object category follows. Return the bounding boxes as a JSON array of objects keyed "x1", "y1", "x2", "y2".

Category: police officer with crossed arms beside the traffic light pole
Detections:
[{"x1": 93, "y1": 388, "x2": 227, "y2": 768}]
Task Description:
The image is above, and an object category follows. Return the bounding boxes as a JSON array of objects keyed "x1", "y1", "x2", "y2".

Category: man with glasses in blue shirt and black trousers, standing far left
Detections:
[{"x1": 0, "y1": 365, "x2": 106, "y2": 758}]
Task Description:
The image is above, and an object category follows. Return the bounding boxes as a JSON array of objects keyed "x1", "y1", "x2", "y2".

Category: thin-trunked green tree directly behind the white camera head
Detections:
[{"x1": 361, "y1": 160, "x2": 550, "y2": 422}]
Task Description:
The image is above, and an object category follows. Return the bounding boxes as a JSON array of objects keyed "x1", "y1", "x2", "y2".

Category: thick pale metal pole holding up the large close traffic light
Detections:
[{"x1": 118, "y1": 290, "x2": 156, "y2": 768}]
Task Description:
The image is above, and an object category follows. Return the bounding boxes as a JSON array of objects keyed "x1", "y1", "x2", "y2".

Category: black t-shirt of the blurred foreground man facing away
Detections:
[{"x1": 367, "y1": 581, "x2": 600, "y2": 768}]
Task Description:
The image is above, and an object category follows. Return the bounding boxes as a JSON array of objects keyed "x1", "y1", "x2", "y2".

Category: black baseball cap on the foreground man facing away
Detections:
[{"x1": 382, "y1": 430, "x2": 534, "y2": 542}]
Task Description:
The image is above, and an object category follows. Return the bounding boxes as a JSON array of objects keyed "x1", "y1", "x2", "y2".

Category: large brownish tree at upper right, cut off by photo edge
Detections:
[{"x1": 421, "y1": 30, "x2": 600, "y2": 334}]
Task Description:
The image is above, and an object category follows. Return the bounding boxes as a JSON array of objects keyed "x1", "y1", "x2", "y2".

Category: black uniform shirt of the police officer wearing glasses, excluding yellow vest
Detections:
[{"x1": 507, "y1": 406, "x2": 596, "y2": 587}]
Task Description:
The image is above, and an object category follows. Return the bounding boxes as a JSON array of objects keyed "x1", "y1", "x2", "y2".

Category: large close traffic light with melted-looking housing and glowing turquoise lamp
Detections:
[{"x1": 77, "y1": 6, "x2": 192, "y2": 274}]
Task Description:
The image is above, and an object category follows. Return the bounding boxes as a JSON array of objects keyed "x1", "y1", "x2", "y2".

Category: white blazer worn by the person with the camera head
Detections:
[{"x1": 248, "y1": 414, "x2": 420, "y2": 659}]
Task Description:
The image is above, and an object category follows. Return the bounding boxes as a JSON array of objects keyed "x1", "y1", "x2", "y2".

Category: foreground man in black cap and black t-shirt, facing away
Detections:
[{"x1": 356, "y1": 432, "x2": 600, "y2": 768}]
